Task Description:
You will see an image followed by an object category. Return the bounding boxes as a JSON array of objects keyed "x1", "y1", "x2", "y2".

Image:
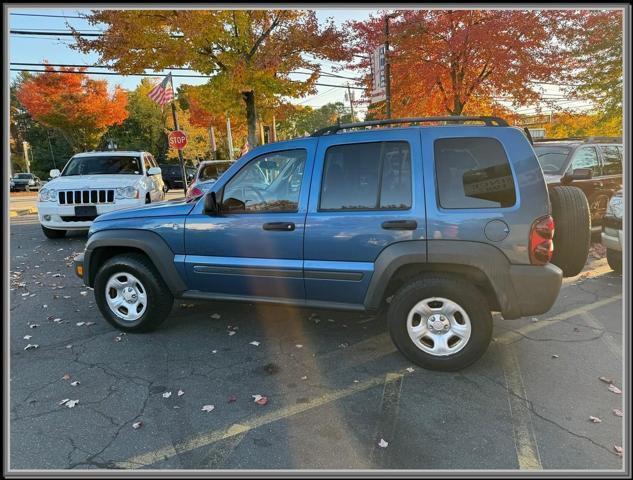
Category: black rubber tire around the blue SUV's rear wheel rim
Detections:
[{"x1": 387, "y1": 274, "x2": 492, "y2": 371}]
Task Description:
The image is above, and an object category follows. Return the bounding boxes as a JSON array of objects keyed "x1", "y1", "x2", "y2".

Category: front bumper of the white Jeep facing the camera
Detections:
[{"x1": 37, "y1": 198, "x2": 145, "y2": 230}]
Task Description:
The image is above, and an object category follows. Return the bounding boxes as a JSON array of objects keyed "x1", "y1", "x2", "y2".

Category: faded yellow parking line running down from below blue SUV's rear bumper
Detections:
[{"x1": 501, "y1": 345, "x2": 543, "y2": 470}]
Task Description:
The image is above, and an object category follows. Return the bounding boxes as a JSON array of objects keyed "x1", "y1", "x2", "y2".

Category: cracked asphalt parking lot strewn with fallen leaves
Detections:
[{"x1": 10, "y1": 215, "x2": 628, "y2": 470}]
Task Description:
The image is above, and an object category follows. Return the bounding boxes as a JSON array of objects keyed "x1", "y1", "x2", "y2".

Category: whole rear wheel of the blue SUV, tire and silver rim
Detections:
[{"x1": 387, "y1": 275, "x2": 492, "y2": 371}]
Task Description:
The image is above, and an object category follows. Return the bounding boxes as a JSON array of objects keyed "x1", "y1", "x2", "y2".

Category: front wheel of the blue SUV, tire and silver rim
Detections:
[{"x1": 94, "y1": 253, "x2": 174, "y2": 332}]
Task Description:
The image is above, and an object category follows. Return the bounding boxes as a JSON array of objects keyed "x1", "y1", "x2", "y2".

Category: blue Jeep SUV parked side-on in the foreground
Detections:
[{"x1": 75, "y1": 117, "x2": 562, "y2": 370}]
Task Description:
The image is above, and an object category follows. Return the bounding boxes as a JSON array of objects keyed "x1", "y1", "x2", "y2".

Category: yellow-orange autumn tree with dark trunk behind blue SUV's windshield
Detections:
[{"x1": 74, "y1": 9, "x2": 348, "y2": 146}]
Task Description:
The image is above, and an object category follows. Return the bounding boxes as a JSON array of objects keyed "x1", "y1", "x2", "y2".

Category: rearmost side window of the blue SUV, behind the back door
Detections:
[{"x1": 434, "y1": 137, "x2": 516, "y2": 208}]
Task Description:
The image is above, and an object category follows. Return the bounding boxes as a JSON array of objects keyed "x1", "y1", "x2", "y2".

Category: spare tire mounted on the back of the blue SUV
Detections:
[{"x1": 549, "y1": 186, "x2": 591, "y2": 277}]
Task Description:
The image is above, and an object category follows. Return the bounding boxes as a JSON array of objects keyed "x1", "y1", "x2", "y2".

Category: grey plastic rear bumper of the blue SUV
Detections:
[{"x1": 502, "y1": 263, "x2": 563, "y2": 319}]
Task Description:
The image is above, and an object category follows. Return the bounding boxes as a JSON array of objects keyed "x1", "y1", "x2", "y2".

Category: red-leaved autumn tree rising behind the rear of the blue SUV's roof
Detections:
[{"x1": 348, "y1": 9, "x2": 572, "y2": 116}]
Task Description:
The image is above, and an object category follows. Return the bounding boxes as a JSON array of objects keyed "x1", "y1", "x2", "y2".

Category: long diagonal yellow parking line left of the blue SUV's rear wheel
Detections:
[{"x1": 116, "y1": 376, "x2": 396, "y2": 468}]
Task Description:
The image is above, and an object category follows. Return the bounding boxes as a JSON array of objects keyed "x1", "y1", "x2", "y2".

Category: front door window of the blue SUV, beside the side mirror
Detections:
[{"x1": 222, "y1": 150, "x2": 307, "y2": 213}]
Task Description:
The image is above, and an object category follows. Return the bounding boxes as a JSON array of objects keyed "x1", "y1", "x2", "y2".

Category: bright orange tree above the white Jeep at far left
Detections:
[{"x1": 17, "y1": 65, "x2": 127, "y2": 152}]
